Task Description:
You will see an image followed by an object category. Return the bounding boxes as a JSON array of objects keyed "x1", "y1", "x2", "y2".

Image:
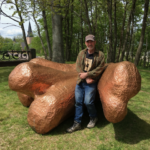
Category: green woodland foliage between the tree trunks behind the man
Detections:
[{"x1": 0, "y1": 0, "x2": 150, "y2": 63}]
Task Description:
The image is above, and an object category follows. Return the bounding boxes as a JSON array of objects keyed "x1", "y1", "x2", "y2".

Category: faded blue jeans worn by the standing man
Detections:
[{"x1": 74, "y1": 82, "x2": 97, "y2": 123}]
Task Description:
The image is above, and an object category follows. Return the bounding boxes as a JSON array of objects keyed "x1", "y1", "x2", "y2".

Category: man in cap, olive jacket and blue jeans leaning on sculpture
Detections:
[{"x1": 66, "y1": 34, "x2": 105, "y2": 133}]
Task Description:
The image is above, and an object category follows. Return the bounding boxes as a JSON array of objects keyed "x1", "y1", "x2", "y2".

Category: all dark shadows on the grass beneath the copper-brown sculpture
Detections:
[{"x1": 45, "y1": 101, "x2": 150, "y2": 144}]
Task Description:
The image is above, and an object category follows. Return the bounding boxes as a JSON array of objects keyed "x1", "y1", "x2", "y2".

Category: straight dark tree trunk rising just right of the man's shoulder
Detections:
[{"x1": 107, "y1": 0, "x2": 113, "y2": 63}]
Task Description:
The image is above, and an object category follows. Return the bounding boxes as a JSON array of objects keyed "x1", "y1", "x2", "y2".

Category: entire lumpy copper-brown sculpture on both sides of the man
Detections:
[{"x1": 9, "y1": 58, "x2": 141, "y2": 134}]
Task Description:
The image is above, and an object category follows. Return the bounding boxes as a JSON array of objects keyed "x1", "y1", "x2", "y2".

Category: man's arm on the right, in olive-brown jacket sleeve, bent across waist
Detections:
[{"x1": 87, "y1": 53, "x2": 105, "y2": 79}]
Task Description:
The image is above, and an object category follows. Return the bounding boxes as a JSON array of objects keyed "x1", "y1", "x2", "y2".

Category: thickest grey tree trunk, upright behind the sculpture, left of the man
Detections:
[{"x1": 52, "y1": 5, "x2": 64, "y2": 63}]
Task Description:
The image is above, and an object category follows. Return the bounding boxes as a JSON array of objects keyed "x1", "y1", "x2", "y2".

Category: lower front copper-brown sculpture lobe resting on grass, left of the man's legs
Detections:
[{"x1": 27, "y1": 77, "x2": 76, "y2": 134}]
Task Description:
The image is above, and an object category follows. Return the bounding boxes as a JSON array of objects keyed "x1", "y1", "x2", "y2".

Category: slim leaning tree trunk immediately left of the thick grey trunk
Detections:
[{"x1": 42, "y1": 10, "x2": 52, "y2": 60}]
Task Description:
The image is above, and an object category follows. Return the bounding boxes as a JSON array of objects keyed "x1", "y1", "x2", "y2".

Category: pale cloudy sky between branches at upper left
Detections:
[{"x1": 0, "y1": 2, "x2": 35, "y2": 39}]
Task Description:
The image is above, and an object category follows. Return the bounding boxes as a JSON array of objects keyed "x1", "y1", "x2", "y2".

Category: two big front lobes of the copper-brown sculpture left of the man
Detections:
[{"x1": 9, "y1": 59, "x2": 77, "y2": 134}]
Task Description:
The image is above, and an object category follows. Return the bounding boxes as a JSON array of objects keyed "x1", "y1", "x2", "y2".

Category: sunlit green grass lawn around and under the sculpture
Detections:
[{"x1": 0, "y1": 64, "x2": 150, "y2": 150}]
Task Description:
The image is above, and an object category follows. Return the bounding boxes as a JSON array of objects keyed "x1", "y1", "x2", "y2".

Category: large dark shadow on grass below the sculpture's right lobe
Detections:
[{"x1": 114, "y1": 109, "x2": 150, "y2": 144}]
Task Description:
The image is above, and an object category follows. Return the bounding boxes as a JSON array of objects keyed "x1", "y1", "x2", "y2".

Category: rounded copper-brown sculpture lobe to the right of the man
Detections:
[{"x1": 98, "y1": 61, "x2": 141, "y2": 123}]
